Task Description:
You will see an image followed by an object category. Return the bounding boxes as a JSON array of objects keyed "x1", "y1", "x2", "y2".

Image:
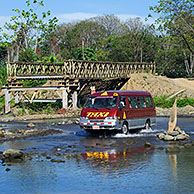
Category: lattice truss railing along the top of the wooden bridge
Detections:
[{"x1": 7, "y1": 60, "x2": 155, "y2": 80}]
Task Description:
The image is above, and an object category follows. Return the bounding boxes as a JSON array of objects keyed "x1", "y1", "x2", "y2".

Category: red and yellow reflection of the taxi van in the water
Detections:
[{"x1": 81, "y1": 146, "x2": 155, "y2": 174}]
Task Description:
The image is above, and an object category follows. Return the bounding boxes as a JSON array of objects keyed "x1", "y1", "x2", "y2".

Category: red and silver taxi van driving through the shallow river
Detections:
[{"x1": 80, "y1": 91, "x2": 156, "y2": 134}]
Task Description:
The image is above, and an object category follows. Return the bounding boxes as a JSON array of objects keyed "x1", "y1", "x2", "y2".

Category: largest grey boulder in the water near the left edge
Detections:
[{"x1": 3, "y1": 149, "x2": 25, "y2": 162}]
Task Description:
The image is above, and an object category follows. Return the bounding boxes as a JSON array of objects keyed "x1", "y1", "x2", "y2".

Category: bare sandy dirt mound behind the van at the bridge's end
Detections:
[{"x1": 121, "y1": 73, "x2": 194, "y2": 98}]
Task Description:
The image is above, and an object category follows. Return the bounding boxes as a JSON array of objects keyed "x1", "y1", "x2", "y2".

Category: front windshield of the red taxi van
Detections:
[{"x1": 84, "y1": 96, "x2": 118, "y2": 109}]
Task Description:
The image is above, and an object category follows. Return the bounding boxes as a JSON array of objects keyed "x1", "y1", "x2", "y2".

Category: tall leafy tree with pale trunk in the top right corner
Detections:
[{"x1": 150, "y1": 0, "x2": 194, "y2": 76}]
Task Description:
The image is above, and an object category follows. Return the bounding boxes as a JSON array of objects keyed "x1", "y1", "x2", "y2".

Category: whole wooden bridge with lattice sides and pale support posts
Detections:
[{"x1": 3, "y1": 60, "x2": 155, "y2": 113}]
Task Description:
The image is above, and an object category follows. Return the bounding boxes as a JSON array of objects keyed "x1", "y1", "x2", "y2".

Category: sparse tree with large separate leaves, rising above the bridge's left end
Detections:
[{"x1": 3, "y1": 0, "x2": 58, "y2": 60}]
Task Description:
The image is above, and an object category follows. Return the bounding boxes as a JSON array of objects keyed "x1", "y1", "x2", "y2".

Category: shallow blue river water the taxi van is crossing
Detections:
[{"x1": 0, "y1": 117, "x2": 194, "y2": 194}]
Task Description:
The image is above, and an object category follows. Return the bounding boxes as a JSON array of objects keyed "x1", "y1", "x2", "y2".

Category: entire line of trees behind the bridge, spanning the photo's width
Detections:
[{"x1": 0, "y1": 0, "x2": 194, "y2": 78}]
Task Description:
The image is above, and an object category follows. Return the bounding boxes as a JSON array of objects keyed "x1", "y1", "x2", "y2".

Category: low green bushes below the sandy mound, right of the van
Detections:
[{"x1": 153, "y1": 96, "x2": 194, "y2": 108}]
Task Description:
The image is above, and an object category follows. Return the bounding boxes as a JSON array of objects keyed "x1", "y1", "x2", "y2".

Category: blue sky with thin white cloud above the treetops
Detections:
[{"x1": 0, "y1": 0, "x2": 158, "y2": 26}]
